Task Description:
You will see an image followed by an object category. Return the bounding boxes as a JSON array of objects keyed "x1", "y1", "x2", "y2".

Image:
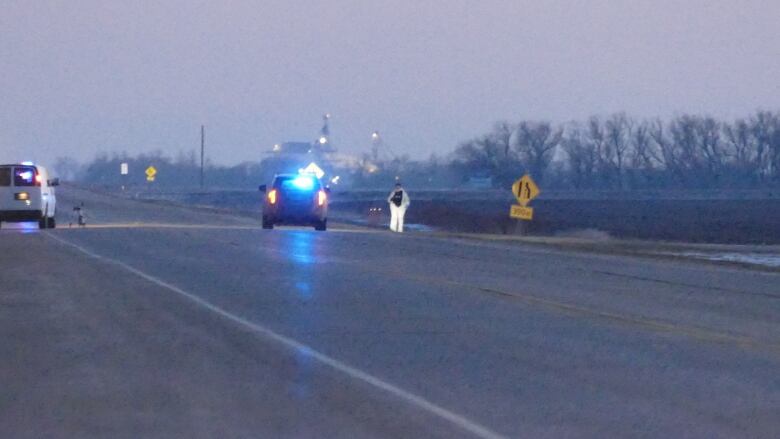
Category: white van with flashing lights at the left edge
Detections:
[{"x1": 0, "y1": 163, "x2": 60, "y2": 229}]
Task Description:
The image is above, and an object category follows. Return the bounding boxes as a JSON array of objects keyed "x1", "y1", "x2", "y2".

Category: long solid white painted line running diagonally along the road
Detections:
[{"x1": 44, "y1": 232, "x2": 505, "y2": 439}]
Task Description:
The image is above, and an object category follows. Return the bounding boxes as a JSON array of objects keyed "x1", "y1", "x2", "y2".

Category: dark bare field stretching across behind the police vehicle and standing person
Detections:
[{"x1": 116, "y1": 187, "x2": 780, "y2": 244}]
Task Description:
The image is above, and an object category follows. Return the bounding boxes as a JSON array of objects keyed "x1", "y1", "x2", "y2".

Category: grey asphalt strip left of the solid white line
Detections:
[{"x1": 0, "y1": 234, "x2": 476, "y2": 438}]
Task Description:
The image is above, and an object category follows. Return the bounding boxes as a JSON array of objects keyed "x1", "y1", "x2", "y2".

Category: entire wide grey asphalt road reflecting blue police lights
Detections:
[{"x1": 0, "y1": 188, "x2": 780, "y2": 438}]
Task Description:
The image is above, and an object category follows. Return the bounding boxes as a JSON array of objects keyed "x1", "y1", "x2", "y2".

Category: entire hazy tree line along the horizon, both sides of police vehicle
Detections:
[{"x1": 65, "y1": 111, "x2": 780, "y2": 190}]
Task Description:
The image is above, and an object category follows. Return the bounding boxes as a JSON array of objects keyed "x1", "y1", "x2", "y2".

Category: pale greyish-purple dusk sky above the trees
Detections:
[{"x1": 0, "y1": 0, "x2": 780, "y2": 164}]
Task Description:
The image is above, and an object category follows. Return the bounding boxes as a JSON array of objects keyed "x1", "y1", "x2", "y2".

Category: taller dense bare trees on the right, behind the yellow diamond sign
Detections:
[{"x1": 453, "y1": 111, "x2": 780, "y2": 190}]
